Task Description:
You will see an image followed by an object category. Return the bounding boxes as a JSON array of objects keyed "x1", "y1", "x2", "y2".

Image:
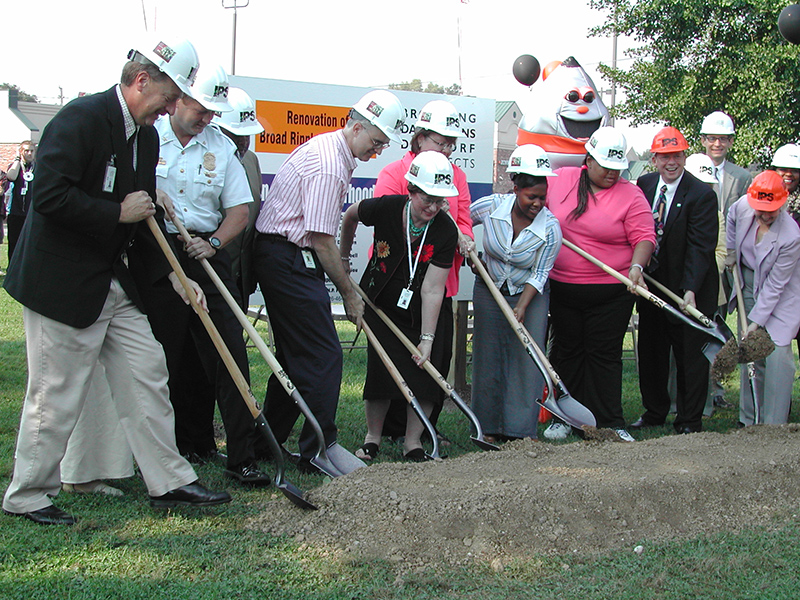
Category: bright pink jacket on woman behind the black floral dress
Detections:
[{"x1": 375, "y1": 151, "x2": 474, "y2": 298}]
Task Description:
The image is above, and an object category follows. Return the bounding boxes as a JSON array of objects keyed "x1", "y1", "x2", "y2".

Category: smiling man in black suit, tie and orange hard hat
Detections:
[{"x1": 630, "y1": 127, "x2": 719, "y2": 433}]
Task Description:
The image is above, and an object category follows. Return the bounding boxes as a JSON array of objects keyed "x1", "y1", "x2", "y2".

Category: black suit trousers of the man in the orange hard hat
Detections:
[{"x1": 637, "y1": 300, "x2": 708, "y2": 431}]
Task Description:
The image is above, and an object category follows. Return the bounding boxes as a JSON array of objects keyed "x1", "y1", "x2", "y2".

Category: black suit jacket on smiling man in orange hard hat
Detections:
[{"x1": 637, "y1": 171, "x2": 719, "y2": 315}]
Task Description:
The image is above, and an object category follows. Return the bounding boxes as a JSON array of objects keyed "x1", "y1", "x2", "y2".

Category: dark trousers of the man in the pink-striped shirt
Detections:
[{"x1": 253, "y1": 235, "x2": 342, "y2": 459}]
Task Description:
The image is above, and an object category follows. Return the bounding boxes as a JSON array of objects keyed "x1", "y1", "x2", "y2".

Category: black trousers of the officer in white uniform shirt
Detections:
[{"x1": 142, "y1": 236, "x2": 260, "y2": 467}]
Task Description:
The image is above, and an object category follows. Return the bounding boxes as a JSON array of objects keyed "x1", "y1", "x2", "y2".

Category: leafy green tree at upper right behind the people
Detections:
[{"x1": 590, "y1": 0, "x2": 800, "y2": 165}]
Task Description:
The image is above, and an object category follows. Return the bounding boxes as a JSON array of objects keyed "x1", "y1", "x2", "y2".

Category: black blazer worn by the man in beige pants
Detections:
[{"x1": 4, "y1": 87, "x2": 170, "y2": 328}]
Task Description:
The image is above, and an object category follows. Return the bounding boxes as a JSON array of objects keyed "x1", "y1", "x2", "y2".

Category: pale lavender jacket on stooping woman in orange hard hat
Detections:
[{"x1": 727, "y1": 196, "x2": 800, "y2": 346}]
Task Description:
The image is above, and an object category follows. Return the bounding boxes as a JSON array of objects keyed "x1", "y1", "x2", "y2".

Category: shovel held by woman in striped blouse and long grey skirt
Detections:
[{"x1": 447, "y1": 212, "x2": 597, "y2": 429}]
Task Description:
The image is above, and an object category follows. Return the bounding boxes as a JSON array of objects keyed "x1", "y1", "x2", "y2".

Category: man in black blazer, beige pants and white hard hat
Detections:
[{"x1": 3, "y1": 41, "x2": 231, "y2": 525}]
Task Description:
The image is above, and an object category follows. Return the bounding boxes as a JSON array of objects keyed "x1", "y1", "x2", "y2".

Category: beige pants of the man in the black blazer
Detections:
[{"x1": 3, "y1": 280, "x2": 197, "y2": 513}]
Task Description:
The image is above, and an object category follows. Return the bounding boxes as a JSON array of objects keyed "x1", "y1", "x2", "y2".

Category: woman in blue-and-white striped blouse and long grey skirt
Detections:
[{"x1": 471, "y1": 144, "x2": 561, "y2": 441}]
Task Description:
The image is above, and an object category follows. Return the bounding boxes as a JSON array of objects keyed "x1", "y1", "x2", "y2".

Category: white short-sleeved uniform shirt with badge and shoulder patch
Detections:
[{"x1": 156, "y1": 115, "x2": 248, "y2": 233}]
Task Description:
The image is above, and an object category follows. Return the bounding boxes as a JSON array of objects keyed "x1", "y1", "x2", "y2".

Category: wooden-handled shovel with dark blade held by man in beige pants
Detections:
[{"x1": 147, "y1": 217, "x2": 317, "y2": 510}]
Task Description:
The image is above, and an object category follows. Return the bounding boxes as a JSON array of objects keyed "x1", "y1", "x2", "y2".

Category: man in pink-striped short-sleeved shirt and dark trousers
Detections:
[{"x1": 253, "y1": 90, "x2": 405, "y2": 472}]
